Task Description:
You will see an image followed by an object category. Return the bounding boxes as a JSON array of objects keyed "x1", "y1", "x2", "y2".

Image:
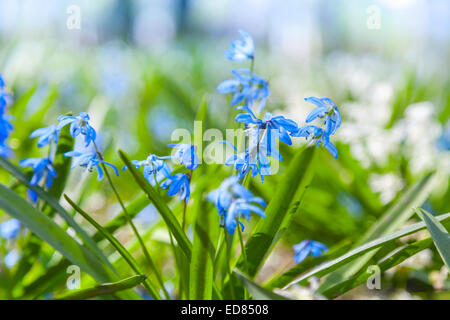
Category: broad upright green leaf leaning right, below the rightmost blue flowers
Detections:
[{"x1": 238, "y1": 147, "x2": 316, "y2": 277}]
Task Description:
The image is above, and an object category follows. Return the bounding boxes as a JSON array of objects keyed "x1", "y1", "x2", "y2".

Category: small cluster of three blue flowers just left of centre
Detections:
[{"x1": 129, "y1": 143, "x2": 199, "y2": 203}]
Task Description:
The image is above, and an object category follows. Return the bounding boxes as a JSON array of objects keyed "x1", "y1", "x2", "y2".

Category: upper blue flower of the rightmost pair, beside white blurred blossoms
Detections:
[{"x1": 305, "y1": 97, "x2": 341, "y2": 135}]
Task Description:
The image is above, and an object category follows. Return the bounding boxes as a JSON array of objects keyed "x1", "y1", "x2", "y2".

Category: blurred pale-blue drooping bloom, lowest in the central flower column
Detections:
[{"x1": 207, "y1": 176, "x2": 266, "y2": 234}]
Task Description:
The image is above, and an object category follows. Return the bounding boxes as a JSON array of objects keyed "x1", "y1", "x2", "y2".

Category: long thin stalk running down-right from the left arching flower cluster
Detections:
[{"x1": 93, "y1": 142, "x2": 170, "y2": 299}]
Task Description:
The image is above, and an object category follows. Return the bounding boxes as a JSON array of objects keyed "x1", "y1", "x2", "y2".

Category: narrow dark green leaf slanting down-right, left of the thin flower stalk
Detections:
[{"x1": 64, "y1": 195, "x2": 161, "y2": 300}]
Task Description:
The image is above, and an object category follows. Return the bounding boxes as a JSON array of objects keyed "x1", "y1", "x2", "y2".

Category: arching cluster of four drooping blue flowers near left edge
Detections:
[{"x1": 20, "y1": 112, "x2": 119, "y2": 203}]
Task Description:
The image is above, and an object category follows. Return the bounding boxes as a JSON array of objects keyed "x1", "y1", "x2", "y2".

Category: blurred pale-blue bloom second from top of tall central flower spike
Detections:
[{"x1": 217, "y1": 69, "x2": 270, "y2": 112}]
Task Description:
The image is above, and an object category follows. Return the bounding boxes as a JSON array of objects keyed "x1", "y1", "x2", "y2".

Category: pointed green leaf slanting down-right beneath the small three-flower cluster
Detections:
[{"x1": 119, "y1": 150, "x2": 192, "y2": 260}]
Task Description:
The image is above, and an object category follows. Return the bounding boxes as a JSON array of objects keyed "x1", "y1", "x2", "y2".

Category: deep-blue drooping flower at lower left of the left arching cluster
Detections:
[{"x1": 19, "y1": 158, "x2": 57, "y2": 203}]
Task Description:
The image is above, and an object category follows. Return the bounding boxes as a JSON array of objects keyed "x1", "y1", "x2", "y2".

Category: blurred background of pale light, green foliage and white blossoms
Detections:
[{"x1": 0, "y1": 0, "x2": 450, "y2": 298}]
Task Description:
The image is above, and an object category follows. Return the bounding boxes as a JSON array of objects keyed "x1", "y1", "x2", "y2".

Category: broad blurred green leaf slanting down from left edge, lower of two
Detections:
[{"x1": 0, "y1": 184, "x2": 111, "y2": 282}]
